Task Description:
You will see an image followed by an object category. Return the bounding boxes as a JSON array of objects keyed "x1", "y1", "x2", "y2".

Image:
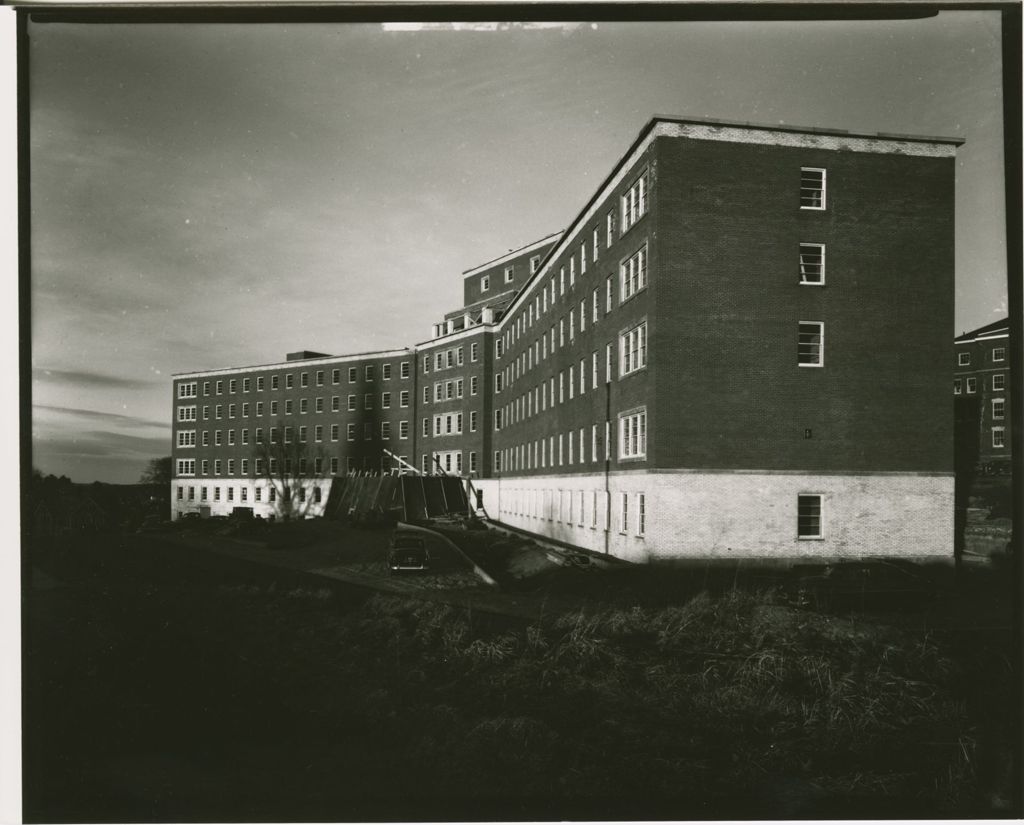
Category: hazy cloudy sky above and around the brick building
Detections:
[{"x1": 29, "y1": 11, "x2": 1007, "y2": 483}]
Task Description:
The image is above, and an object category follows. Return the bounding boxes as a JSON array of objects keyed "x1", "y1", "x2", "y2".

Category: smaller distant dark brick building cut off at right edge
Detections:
[{"x1": 953, "y1": 319, "x2": 1013, "y2": 475}]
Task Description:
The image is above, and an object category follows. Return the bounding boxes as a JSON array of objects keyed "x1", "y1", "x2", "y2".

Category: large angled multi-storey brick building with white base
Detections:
[{"x1": 172, "y1": 117, "x2": 962, "y2": 560}]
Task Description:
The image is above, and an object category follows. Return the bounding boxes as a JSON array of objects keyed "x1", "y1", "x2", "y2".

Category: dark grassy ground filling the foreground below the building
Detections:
[{"x1": 24, "y1": 534, "x2": 1020, "y2": 822}]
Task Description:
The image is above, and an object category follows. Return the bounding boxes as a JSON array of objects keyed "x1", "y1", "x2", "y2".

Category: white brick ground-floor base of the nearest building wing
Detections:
[{"x1": 473, "y1": 471, "x2": 953, "y2": 562}]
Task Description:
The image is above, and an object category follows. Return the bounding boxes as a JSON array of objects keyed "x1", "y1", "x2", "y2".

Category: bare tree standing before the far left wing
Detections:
[{"x1": 253, "y1": 420, "x2": 327, "y2": 520}]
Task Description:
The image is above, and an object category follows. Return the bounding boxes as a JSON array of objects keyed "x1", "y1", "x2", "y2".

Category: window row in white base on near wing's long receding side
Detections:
[{"x1": 500, "y1": 489, "x2": 647, "y2": 538}]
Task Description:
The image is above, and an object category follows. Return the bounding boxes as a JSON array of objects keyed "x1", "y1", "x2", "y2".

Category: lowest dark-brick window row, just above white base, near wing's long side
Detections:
[{"x1": 494, "y1": 407, "x2": 647, "y2": 473}]
